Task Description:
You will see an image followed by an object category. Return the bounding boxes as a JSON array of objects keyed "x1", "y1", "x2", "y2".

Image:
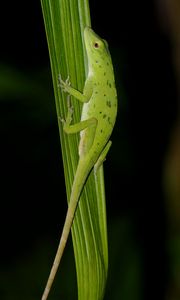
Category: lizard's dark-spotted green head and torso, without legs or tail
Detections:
[{"x1": 79, "y1": 27, "x2": 117, "y2": 159}]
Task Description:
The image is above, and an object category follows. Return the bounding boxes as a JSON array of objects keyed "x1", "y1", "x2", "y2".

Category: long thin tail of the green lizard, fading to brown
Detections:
[{"x1": 41, "y1": 159, "x2": 92, "y2": 300}]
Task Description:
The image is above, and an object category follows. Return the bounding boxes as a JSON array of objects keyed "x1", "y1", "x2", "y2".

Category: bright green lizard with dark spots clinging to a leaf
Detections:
[{"x1": 42, "y1": 27, "x2": 117, "y2": 300}]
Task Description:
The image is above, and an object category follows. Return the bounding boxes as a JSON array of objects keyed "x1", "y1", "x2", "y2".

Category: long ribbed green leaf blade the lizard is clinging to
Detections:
[{"x1": 41, "y1": 0, "x2": 108, "y2": 300}]
